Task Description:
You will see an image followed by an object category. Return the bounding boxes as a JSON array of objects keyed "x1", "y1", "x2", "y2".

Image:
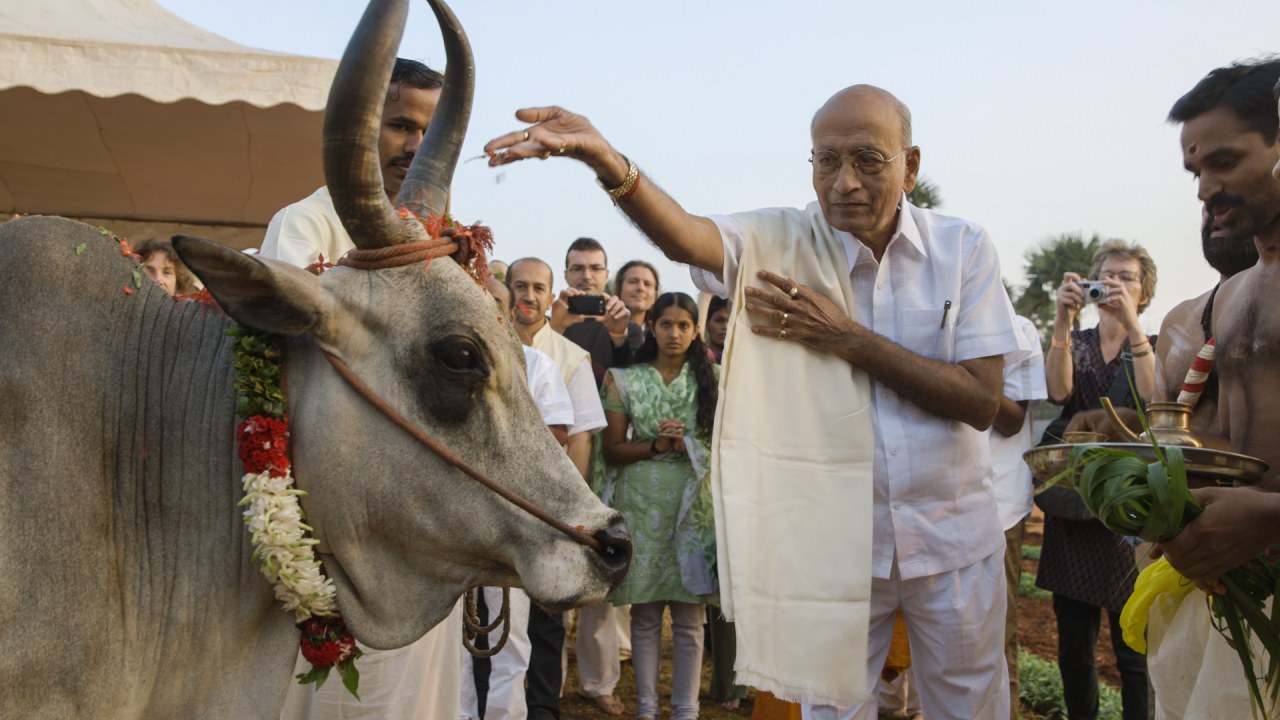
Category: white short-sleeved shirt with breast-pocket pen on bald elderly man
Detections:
[{"x1": 691, "y1": 195, "x2": 1020, "y2": 579}]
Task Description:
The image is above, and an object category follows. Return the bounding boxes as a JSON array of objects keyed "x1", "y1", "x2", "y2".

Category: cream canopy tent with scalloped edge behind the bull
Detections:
[{"x1": 0, "y1": 0, "x2": 338, "y2": 247}]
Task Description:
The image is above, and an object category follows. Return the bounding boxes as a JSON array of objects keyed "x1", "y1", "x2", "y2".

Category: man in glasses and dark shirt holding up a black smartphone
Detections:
[{"x1": 552, "y1": 237, "x2": 644, "y2": 386}]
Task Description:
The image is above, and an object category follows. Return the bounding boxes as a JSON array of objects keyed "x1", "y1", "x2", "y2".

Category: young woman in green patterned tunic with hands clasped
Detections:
[{"x1": 596, "y1": 292, "x2": 719, "y2": 720}]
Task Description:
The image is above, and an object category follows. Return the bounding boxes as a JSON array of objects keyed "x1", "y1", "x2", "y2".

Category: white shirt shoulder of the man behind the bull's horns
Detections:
[{"x1": 259, "y1": 187, "x2": 356, "y2": 268}]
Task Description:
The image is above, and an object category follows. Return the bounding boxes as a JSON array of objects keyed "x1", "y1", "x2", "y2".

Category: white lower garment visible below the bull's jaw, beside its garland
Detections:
[{"x1": 280, "y1": 603, "x2": 462, "y2": 720}]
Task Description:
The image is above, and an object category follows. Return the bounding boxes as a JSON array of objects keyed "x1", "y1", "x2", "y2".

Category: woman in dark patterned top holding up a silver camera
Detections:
[{"x1": 1036, "y1": 240, "x2": 1156, "y2": 720}]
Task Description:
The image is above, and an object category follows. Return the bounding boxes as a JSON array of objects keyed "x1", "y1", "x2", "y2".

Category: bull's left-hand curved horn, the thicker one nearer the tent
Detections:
[{"x1": 324, "y1": 0, "x2": 426, "y2": 249}]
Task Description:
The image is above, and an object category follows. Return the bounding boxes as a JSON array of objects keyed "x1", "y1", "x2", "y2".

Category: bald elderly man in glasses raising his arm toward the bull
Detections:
[{"x1": 486, "y1": 86, "x2": 1020, "y2": 720}]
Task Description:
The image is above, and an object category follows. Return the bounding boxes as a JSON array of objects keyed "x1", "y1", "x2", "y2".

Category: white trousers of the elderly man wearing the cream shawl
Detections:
[{"x1": 801, "y1": 547, "x2": 1009, "y2": 720}]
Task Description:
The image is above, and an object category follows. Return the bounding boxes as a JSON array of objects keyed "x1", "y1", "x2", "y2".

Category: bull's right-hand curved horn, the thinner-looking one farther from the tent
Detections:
[{"x1": 396, "y1": 0, "x2": 476, "y2": 215}]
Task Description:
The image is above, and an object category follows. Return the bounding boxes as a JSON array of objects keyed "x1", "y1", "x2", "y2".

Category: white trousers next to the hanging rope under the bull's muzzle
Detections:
[{"x1": 458, "y1": 588, "x2": 532, "y2": 720}]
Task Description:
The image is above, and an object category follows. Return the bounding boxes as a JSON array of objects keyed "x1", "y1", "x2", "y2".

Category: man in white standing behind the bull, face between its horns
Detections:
[{"x1": 261, "y1": 59, "x2": 462, "y2": 720}]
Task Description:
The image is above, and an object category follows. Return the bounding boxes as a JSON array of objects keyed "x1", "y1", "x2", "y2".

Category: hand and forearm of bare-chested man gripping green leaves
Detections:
[{"x1": 1155, "y1": 487, "x2": 1280, "y2": 594}]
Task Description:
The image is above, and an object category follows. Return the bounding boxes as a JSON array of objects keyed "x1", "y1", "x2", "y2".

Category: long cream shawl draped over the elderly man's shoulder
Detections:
[{"x1": 712, "y1": 204, "x2": 876, "y2": 705}]
